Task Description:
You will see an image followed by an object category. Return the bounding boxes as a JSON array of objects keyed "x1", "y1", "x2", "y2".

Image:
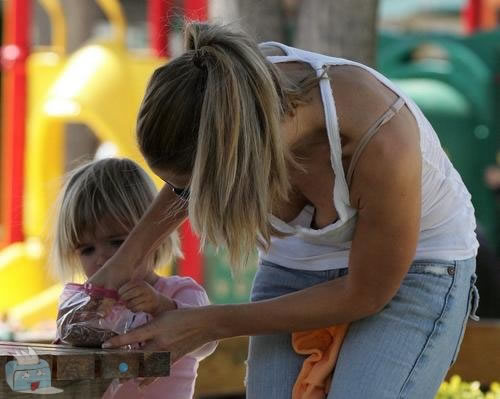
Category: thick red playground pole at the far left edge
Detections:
[{"x1": 1, "y1": 0, "x2": 31, "y2": 245}]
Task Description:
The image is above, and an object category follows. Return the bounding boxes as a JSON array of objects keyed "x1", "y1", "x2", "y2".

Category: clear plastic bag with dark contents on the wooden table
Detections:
[{"x1": 57, "y1": 283, "x2": 150, "y2": 347}]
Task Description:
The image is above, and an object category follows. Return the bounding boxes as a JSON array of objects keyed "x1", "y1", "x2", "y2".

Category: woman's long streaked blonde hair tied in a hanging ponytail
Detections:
[{"x1": 137, "y1": 22, "x2": 317, "y2": 267}]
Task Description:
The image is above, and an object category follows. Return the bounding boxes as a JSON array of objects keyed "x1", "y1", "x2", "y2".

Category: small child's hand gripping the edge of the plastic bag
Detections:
[{"x1": 118, "y1": 281, "x2": 177, "y2": 316}]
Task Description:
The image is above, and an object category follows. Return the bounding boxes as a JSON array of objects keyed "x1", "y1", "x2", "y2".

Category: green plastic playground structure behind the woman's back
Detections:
[{"x1": 378, "y1": 30, "x2": 500, "y2": 253}]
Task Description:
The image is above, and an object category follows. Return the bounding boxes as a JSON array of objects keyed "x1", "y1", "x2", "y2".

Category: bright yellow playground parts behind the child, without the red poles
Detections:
[{"x1": 0, "y1": 0, "x2": 167, "y2": 327}]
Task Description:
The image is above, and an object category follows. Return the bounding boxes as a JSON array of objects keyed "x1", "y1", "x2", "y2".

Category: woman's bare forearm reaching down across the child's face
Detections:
[{"x1": 88, "y1": 185, "x2": 187, "y2": 289}]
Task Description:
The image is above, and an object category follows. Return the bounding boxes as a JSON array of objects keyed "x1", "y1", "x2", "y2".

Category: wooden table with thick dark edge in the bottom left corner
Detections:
[{"x1": 0, "y1": 342, "x2": 170, "y2": 399}]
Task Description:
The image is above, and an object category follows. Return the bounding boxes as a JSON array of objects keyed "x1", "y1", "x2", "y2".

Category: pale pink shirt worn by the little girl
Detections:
[{"x1": 57, "y1": 276, "x2": 217, "y2": 399}]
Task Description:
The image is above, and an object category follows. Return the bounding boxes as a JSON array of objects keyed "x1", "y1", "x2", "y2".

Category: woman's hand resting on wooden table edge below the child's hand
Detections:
[{"x1": 102, "y1": 307, "x2": 217, "y2": 364}]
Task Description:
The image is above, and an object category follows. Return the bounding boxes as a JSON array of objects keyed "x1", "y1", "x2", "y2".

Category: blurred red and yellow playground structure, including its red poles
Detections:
[{"x1": 0, "y1": 0, "x2": 221, "y2": 327}]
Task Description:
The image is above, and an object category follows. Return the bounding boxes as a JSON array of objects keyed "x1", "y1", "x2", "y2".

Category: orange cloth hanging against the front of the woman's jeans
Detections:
[{"x1": 292, "y1": 324, "x2": 349, "y2": 399}]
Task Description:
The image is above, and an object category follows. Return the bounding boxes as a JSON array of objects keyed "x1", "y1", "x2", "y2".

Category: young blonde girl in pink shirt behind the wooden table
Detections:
[{"x1": 52, "y1": 158, "x2": 215, "y2": 399}]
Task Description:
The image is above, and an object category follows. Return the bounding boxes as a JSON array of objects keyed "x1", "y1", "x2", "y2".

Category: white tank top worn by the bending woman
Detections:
[{"x1": 259, "y1": 42, "x2": 479, "y2": 270}]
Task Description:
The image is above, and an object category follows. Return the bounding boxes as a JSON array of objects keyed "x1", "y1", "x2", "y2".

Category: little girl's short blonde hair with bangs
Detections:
[{"x1": 51, "y1": 158, "x2": 181, "y2": 280}]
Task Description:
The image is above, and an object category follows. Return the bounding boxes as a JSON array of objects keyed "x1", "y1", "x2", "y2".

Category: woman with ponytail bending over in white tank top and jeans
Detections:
[{"x1": 91, "y1": 23, "x2": 477, "y2": 399}]
